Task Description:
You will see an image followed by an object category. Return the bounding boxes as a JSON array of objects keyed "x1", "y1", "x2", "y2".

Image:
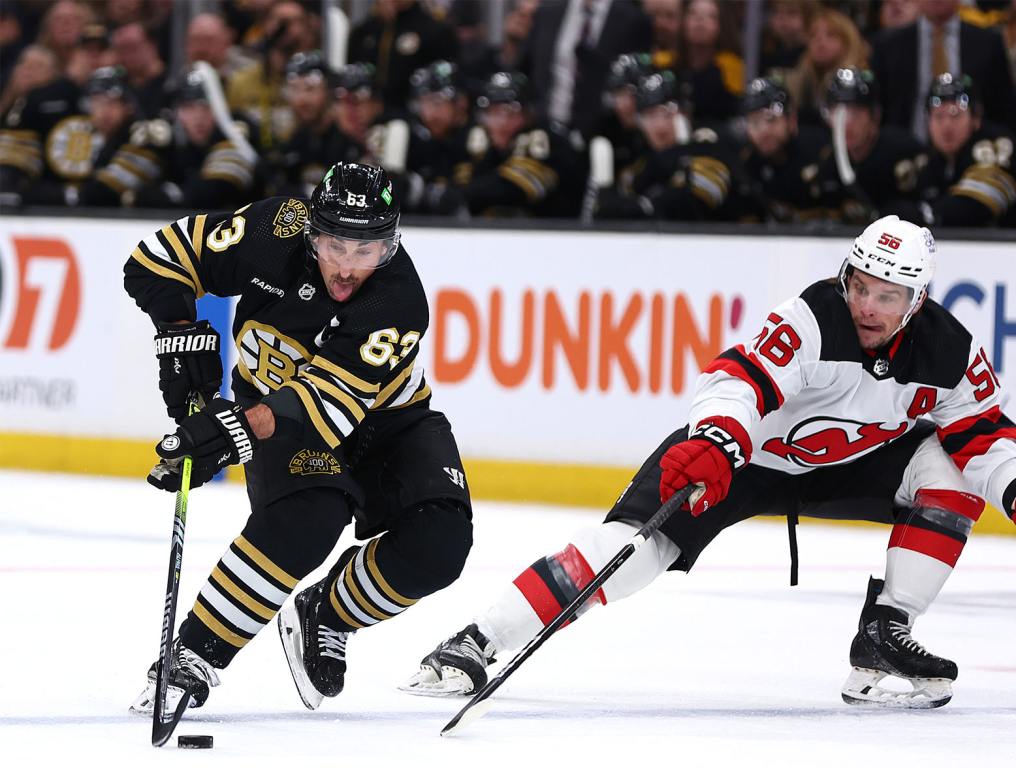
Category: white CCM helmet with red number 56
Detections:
[{"x1": 839, "y1": 215, "x2": 936, "y2": 331}]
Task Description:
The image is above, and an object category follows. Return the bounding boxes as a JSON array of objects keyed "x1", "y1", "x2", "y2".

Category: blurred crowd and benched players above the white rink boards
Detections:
[{"x1": 0, "y1": 0, "x2": 1016, "y2": 228}]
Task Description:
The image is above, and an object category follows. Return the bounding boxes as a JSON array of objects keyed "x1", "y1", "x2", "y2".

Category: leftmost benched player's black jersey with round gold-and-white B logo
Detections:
[{"x1": 0, "y1": 79, "x2": 103, "y2": 204}]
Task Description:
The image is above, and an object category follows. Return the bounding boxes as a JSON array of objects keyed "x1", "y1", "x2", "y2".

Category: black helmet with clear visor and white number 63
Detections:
[{"x1": 304, "y1": 163, "x2": 401, "y2": 268}]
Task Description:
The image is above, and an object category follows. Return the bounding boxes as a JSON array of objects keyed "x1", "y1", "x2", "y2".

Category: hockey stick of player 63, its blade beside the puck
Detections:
[{"x1": 151, "y1": 395, "x2": 197, "y2": 747}]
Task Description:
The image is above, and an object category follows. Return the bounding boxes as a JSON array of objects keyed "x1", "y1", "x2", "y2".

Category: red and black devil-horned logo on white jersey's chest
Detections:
[{"x1": 762, "y1": 417, "x2": 907, "y2": 466}]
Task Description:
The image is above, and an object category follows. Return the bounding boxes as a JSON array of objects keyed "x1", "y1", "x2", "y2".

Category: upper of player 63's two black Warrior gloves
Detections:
[{"x1": 155, "y1": 320, "x2": 223, "y2": 424}]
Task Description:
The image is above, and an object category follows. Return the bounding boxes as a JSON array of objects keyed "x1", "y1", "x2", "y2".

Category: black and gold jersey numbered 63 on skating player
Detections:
[{"x1": 124, "y1": 197, "x2": 431, "y2": 450}]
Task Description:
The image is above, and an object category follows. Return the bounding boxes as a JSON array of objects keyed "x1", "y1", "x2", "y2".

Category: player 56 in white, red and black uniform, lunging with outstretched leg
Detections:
[{"x1": 403, "y1": 216, "x2": 1016, "y2": 708}]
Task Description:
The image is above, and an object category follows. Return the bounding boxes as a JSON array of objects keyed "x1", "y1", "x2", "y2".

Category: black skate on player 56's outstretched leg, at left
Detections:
[{"x1": 399, "y1": 624, "x2": 497, "y2": 696}]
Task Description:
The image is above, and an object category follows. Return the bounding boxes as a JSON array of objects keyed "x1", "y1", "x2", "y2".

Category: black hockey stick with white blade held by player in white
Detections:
[{"x1": 441, "y1": 486, "x2": 696, "y2": 735}]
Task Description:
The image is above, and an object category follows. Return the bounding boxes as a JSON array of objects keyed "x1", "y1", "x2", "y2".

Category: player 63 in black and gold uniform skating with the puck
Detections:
[{"x1": 124, "y1": 164, "x2": 472, "y2": 712}]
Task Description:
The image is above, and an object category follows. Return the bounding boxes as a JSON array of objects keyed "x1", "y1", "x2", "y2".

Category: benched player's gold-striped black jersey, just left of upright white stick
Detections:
[{"x1": 453, "y1": 120, "x2": 585, "y2": 216}]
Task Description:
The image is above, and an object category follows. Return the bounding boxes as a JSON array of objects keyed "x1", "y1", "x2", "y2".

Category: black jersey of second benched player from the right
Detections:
[{"x1": 815, "y1": 126, "x2": 928, "y2": 225}]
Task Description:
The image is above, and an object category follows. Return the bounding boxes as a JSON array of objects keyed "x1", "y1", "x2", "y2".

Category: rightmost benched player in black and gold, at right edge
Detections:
[{"x1": 905, "y1": 73, "x2": 1016, "y2": 227}]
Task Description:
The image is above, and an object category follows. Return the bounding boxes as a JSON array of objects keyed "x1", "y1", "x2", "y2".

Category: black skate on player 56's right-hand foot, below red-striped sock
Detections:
[{"x1": 842, "y1": 578, "x2": 957, "y2": 709}]
